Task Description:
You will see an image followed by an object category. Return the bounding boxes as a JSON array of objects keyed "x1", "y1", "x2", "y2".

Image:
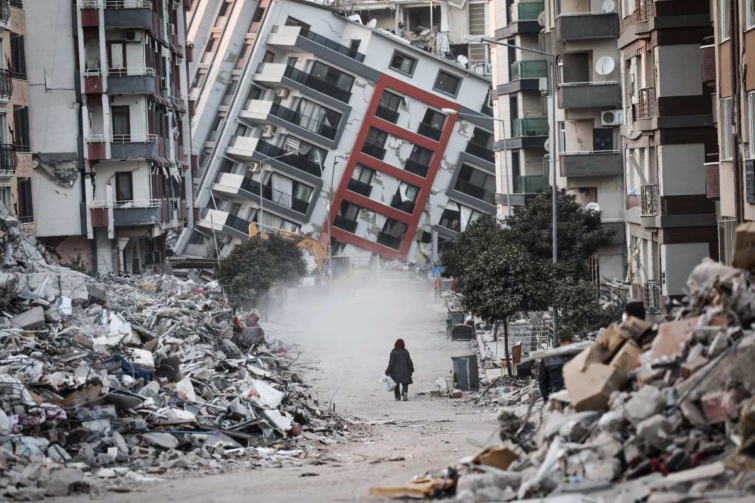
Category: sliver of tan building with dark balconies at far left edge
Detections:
[{"x1": 0, "y1": 0, "x2": 34, "y2": 231}]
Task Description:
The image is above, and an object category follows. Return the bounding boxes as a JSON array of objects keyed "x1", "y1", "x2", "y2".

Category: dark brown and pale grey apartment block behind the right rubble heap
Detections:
[{"x1": 619, "y1": 0, "x2": 726, "y2": 310}]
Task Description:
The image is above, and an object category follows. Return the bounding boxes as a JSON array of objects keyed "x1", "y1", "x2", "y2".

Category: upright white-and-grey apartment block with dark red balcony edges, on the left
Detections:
[{"x1": 26, "y1": 0, "x2": 192, "y2": 274}]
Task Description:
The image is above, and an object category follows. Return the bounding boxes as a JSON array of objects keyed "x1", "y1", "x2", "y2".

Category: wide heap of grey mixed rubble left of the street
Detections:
[{"x1": 0, "y1": 208, "x2": 350, "y2": 500}]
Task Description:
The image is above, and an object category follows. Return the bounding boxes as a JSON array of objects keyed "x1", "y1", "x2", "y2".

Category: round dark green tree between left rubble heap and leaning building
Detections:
[{"x1": 215, "y1": 234, "x2": 307, "y2": 307}]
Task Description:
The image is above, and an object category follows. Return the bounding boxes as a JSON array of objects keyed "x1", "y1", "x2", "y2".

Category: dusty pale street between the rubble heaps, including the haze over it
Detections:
[{"x1": 68, "y1": 277, "x2": 497, "y2": 502}]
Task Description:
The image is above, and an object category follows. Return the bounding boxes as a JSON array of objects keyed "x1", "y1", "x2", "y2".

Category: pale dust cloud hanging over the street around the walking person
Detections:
[{"x1": 266, "y1": 271, "x2": 450, "y2": 414}]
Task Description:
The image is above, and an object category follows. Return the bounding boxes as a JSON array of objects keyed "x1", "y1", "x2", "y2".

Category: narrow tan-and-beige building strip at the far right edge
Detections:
[{"x1": 701, "y1": 0, "x2": 755, "y2": 264}]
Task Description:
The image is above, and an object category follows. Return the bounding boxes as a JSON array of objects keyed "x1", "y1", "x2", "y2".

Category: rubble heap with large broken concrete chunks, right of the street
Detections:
[{"x1": 376, "y1": 260, "x2": 755, "y2": 502}]
